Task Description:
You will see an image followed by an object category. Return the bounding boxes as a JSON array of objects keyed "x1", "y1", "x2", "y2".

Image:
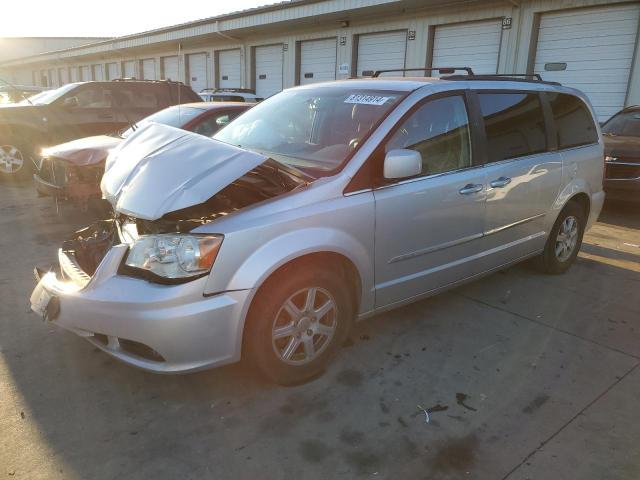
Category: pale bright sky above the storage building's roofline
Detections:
[{"x1": 0, "y1": 0, "x2": 277, "y2": 37}]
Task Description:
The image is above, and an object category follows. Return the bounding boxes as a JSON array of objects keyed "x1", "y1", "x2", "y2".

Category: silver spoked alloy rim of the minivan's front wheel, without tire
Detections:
[{"x1": 271, "y1": 287, "x2": 338, "y2": 365}]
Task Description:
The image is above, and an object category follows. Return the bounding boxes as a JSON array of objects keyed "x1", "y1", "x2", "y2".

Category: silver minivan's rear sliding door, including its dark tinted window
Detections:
[{"x1": 478, "y1": 91, "x2": 562, "y2": 262}]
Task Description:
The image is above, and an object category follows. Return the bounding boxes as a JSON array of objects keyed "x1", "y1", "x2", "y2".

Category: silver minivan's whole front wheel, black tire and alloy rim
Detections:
[{"x1": 244, "y1": 264, "x2": 353, "y2": 385}]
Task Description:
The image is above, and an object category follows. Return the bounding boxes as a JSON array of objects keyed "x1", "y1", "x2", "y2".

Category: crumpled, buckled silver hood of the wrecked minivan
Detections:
[{"x1": 100, "y1": 123, "x2": 267, "y2": 220}]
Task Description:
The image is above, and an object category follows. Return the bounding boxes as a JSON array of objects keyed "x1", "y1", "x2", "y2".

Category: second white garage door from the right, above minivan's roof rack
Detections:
[{"x1": 432, "y1": 20, "x2": 502, "y2": 74}]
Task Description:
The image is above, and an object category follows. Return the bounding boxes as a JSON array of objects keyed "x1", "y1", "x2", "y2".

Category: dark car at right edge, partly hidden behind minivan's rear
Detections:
[{"x1": 602, "y1": 106, "x2": 640, "y2": 202}]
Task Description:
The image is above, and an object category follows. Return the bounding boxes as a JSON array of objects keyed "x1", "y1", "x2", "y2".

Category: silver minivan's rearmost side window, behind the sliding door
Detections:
[{"x1": 547, "y1": 93, "x2": 598, "y2": 149}]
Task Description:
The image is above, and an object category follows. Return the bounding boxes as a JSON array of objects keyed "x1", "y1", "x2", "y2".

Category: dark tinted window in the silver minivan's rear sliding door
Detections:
[{"x1": 478, "y1": 92, "x2": 547, "y2": 162}]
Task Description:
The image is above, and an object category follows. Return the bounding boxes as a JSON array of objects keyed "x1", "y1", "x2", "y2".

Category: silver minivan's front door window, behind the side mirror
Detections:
[{"x1": 386, "y1": 96, "x2": 471, "y2": 175}]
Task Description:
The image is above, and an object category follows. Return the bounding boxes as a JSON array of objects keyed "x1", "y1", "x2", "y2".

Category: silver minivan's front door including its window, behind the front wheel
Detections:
[{"x1": 374, "y1": 94, "x2": 486, "y2": 307}]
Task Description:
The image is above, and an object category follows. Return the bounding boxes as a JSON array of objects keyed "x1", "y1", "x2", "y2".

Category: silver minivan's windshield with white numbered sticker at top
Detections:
[{"x1": 213, "y1": 86, "x2": 405, "y2": 172}]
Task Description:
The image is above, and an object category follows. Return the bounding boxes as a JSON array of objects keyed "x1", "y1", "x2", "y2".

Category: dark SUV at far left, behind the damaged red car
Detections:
[{"x1": 0, "y1": 79, "x2": 202, "y2": 179}]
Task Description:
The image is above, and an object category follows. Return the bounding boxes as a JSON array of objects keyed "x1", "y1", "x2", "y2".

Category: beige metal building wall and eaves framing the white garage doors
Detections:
[{"x1": 6, "y1": 0, "x2": 640, "y2": 108}]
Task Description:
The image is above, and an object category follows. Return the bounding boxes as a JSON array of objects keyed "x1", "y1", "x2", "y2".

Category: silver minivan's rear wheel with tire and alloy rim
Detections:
[{"x1": 538, "y1": 202, "x2": 586, "y2": 275}]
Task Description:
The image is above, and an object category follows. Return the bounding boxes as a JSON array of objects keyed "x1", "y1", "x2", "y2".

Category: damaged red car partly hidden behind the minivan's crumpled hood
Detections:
[{"x1": 33, "y1": 102, "x2": 253, "y2": 210}]
